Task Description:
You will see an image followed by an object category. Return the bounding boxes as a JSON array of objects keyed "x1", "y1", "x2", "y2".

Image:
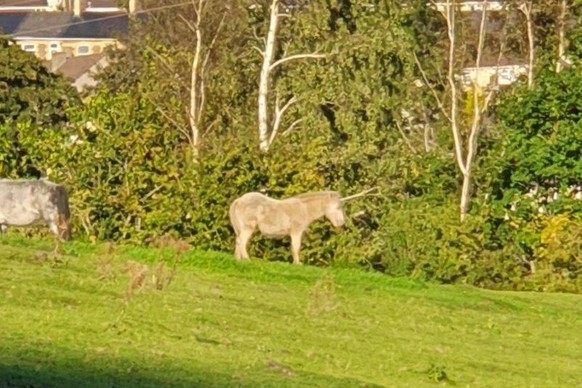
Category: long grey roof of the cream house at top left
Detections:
[{"x1": 0, "y1": 12, "x2": 129, "y2": 39}]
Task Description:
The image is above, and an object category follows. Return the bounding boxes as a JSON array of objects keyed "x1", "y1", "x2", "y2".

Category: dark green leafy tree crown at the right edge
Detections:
[{"x1": 491, "y1": 69, "x2": 582, "y2": 195}]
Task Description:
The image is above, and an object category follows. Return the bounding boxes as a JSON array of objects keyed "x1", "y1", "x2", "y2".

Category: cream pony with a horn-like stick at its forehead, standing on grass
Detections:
[{"x1": 229, "y1": 190, "x2": 371, "y2": 264}]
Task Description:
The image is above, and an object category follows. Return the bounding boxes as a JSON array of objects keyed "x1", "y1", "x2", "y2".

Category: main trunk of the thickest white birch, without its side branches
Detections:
[{"x1": 258, "y1": 0, "x2": 279, "y2": 152}]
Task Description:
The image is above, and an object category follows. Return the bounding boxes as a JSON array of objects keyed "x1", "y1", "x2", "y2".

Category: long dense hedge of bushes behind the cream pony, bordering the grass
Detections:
[{"x1": 8, "y1": 69, "x2": 580, "y2": 291}]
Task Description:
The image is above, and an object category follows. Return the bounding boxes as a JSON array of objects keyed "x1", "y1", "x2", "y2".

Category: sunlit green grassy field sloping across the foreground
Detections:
[{"x1": 0, "y1": 237, "x2": 582, "y2": 387}]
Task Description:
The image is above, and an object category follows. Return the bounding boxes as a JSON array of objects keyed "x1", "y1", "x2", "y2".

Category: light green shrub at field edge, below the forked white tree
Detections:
[{"x1": 382, "y1": 200, "x2": 524, "y2": 288}]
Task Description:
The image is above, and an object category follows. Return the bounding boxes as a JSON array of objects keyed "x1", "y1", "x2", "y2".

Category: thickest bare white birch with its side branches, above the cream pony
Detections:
[{"x1": 258, "y1": 0, "x2": 325, "y2": 152}]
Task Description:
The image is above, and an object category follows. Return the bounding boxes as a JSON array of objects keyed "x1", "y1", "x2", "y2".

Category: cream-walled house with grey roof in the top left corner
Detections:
[{"x1": 0, "y1": 0, "x2": 137, "y2": 91}]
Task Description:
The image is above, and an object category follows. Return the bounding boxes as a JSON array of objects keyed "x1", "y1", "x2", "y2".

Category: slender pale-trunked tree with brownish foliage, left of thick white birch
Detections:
[{"x1": 94, "y1": 0, "x2": 249, "y2": 160}]
